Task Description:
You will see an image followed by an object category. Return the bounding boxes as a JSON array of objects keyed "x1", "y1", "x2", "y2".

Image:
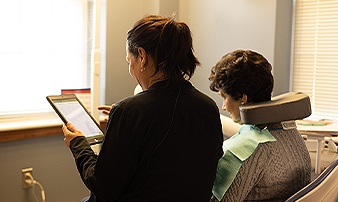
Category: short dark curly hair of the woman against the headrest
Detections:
[{"x1": 209, "y1": 50, "x2": 274, "y2": 103}]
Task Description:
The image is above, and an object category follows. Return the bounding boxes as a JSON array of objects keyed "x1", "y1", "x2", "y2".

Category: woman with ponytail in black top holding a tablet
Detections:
[{"x1": 63, "y1": 16, "x2": 223, "y2": 201}]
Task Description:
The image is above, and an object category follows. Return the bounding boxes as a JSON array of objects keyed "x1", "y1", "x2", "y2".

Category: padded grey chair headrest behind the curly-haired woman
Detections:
[{"x1": 239, "y1": 92, "x2": 312, "y2": 125}]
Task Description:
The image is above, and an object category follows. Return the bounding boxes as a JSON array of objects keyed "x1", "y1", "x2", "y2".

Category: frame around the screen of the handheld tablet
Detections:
[{"x1": 46, "y1": 94, "x2": 104, "y2": 145}]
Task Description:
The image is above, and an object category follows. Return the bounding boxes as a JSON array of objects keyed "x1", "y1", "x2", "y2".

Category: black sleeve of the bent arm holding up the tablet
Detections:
[{"x1": 70, "y1": 102, "x2": 145, "y2": 201}]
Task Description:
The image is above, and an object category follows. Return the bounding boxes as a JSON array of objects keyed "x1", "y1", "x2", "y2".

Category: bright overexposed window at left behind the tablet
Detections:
[{"x1": 0, "y1": 0, "x2": 93, "y2": 116}]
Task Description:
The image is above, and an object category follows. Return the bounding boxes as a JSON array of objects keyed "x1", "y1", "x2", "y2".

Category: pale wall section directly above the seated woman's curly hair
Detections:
[{"x1": 180, "y1": 0, "x2": 276, "y2": 61}]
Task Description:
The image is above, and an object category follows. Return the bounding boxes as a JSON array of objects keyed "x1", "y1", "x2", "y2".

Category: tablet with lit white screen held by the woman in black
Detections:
[{"x1": 46, "y1": 94, "x2": 104, "y2": 145}]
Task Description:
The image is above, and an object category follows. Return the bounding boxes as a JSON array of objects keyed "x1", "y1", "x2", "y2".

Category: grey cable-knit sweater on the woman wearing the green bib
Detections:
[{"x1": 215, "y1": 124, "x2": 311, "y2": 202}]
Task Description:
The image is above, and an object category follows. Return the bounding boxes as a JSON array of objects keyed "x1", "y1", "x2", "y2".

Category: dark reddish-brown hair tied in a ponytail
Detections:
[{"x1": 127, "y1": 15, "x2": 200, "y2": 83}]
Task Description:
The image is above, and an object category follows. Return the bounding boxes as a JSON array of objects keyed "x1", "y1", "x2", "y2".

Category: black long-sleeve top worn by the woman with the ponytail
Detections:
[{"x1": 70, "y1": 81, "x2": 223, "y2": 201}]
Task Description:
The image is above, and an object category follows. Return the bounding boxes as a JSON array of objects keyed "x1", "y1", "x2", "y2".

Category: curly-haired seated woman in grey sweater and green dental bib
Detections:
[{"x1": 209, "y1": 50, "x2": 311, "y2": 202}]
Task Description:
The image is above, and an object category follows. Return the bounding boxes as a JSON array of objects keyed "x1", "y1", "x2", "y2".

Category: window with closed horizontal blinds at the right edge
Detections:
[{"x1": 292, "y1": 0, "x2": 338, "y2": 121}]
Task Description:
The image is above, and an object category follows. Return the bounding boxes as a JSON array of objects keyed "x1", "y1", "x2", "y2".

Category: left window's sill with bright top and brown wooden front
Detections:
[{"x1": 0, "y1": 114, "x2": 106, "y2": 142}]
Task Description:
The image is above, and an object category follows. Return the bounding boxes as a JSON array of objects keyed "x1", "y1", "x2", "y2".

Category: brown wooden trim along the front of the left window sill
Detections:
[{"x1": 0, "y1": 122, "x2": 106, "y2": 142}]
